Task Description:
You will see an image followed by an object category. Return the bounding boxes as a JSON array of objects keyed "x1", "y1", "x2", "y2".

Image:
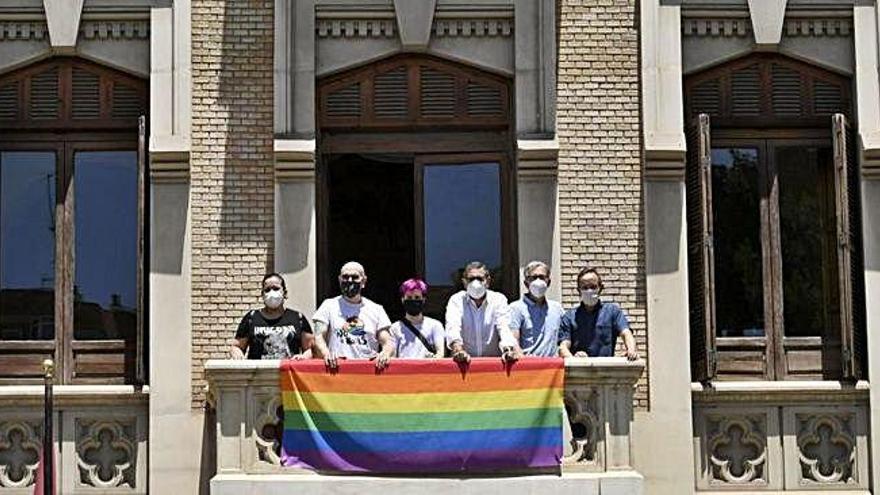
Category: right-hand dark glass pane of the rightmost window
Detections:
[{"x1": 776, "y1": 147, "x2": 838, "y2": 336}]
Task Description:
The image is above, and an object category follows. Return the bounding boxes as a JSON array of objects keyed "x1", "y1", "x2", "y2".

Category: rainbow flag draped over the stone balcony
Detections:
[{"x1": 281, "y1": 358, "x2": 565, "y2": 473}]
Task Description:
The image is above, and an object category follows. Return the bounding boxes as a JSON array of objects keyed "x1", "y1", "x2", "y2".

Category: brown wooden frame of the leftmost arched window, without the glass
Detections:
[{"x1": 0, "y1": 56, "x2": 148, "y2": 385}]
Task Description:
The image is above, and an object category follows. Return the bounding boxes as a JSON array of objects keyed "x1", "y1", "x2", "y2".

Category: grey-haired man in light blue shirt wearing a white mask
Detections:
[{"x1": 510, "y1": 261, "x2": 565, "y2": 357}]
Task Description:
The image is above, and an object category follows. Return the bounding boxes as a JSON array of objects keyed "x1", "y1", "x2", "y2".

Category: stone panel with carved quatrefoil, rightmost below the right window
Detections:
[{"x1": 783, "y1": 406, "x2": 868, "y2": 491}]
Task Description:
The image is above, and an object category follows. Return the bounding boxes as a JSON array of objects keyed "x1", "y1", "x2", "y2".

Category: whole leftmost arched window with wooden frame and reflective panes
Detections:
[{"x1": 0, "y1": 57, "x2": 147, "y2": 383}]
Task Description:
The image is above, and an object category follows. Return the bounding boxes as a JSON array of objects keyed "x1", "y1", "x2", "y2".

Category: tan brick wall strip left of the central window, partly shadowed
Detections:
[{"x1": 190, "y1": 0, "x2": 274, "y2": 407}]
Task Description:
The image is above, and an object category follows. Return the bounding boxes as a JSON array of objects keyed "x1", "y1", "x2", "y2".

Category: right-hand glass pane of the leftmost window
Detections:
[{"x1": 73, "y1": 151, "x2": 138, "y2": 340}]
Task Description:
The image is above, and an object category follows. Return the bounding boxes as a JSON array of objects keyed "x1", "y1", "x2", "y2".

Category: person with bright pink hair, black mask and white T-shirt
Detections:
[{"x1": 391, "y1": 278, "x2": 446, "y2": 359}]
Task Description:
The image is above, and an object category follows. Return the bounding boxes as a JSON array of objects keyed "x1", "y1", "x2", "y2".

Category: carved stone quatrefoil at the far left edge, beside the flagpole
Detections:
[{"x1": 0, "y1": 421, "x2": 40, "y2": 488}]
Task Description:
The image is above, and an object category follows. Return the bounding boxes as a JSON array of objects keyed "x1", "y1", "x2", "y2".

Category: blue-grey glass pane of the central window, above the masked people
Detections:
[{"x1": 424, "y1": 163, "x2": 501, "y2": 285}]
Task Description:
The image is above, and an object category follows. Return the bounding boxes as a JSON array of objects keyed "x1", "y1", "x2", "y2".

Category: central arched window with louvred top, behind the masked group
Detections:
[{"x1": 317, "y1": 55, "x2": 518, "y2": 317}]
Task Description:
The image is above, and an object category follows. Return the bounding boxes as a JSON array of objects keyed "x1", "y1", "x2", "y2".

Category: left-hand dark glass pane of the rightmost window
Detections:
[{"x1": 712, "y1": 148, "x2": 764, "y2": 337}]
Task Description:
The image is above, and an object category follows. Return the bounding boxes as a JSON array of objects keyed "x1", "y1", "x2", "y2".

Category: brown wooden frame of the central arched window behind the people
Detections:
[{"x1": 315, "y1": 54, "x2": 519, "y2": 310}]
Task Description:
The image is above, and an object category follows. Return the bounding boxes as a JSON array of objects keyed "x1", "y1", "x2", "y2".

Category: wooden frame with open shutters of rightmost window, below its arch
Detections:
[{"x1": 688, "y1": 121, "x2": 865, "y2": 380}]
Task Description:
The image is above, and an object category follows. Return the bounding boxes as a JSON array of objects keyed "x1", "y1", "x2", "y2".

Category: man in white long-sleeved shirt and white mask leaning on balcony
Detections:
[{"x1": 446, "y1": 261, "x2": 519, "y2": 363}]
